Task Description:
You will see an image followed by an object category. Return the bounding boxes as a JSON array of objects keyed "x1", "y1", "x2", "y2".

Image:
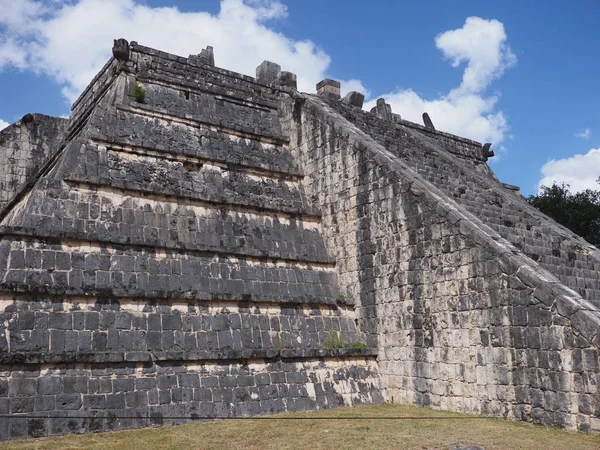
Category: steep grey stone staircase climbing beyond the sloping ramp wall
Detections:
[{"x1": 330, "y1": 98, "x2": 600, "y2": 308}]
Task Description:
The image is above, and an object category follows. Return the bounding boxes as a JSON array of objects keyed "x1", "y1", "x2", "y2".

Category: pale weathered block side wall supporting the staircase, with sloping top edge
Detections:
[{"x1": 286, "y1": 95, "x2": 600, "y2": 430}]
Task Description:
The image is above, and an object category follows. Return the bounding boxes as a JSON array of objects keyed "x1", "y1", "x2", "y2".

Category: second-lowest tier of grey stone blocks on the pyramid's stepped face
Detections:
[{"x1": 0, "y1": 296, "x2": 366, "y2": 364}]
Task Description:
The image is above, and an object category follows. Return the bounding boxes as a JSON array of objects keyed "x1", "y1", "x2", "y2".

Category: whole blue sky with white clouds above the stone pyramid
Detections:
[{"x1": 0, "y1": 0, "x2": 600, "y2": 195}]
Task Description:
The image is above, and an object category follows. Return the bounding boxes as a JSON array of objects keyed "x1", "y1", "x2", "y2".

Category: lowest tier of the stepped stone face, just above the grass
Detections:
[{"x1": 0, "y1": 356, "x2": 380, "y2": 439}]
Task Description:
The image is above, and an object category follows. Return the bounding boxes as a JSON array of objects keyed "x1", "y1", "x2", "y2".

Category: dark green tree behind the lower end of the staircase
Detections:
[{"x1": 527, "y1": 178, "x2": 600, "y2": 248}]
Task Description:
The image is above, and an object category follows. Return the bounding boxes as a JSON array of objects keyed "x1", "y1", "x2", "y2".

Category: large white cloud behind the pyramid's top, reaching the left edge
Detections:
[{"x1": 0, "y1": 0, "x2": 330, "y2": 101}]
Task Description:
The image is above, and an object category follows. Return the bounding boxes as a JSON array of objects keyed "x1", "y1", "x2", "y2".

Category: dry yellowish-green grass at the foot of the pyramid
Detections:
[{"x1": 0, "y1": 405, "x2": 600, "y2": 450}]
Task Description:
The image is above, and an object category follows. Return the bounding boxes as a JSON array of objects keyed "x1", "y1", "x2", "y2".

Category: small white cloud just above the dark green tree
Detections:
[{"x1": 538, "y1": 148, "x2": 600, "y2": 192}]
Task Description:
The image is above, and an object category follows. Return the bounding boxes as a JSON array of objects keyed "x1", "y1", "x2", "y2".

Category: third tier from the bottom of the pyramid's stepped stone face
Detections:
[{"x1": 0, "y1": 234, "x2": 337, "y2": 304}]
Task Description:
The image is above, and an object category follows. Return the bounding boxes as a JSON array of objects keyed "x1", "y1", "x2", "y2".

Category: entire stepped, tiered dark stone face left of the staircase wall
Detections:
[{"x1": 0, "y1": 46, "x2": 385, "y2": 439}]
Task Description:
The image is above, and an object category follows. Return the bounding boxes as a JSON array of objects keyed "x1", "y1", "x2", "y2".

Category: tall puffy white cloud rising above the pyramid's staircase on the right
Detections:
[{"x1": 365, "y1": 17, "x2": 516, "y2": 145}]
